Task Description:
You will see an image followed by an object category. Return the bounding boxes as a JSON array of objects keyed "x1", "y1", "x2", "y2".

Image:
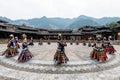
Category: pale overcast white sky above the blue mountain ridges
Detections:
[{"x1": 0, "y1": 0, "x2": 120, "y2": 20}]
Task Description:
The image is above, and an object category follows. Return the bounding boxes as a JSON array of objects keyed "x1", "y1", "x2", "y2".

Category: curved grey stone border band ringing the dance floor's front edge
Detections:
[{"x1": 0, "y1": 55, "x2": 120, "y2": 74}]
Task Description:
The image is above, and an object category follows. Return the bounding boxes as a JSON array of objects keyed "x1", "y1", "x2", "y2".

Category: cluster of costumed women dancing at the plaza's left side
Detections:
[{"x1": 2, "y1": 34, "x2": 33, "y2": 62}]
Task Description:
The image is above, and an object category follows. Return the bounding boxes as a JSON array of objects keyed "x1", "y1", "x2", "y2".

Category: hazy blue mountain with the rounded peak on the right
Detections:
[{"x1": 68, "y1": 15, "x2": 120, "y2": 29}]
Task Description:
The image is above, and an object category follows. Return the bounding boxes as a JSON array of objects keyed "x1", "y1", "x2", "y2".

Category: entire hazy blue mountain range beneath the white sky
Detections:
[{"x1": 0, "y1": 15, "x2": 120, "y2": 29}]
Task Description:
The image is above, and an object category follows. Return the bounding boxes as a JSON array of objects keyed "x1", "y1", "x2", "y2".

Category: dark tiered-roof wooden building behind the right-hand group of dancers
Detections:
[{"x1": 78, "y1": 26, "x2": 112, "y2": 40}]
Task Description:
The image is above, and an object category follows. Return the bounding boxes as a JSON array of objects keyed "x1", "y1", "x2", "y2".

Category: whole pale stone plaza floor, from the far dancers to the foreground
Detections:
[{"x1": 0, "y1": 43, "x2": 120, "y2": 80}]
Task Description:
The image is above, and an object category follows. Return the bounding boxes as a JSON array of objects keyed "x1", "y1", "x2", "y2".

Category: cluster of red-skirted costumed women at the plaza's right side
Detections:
[{"x1": 90, "y1": 36, "x2": 116, "y2": 62}]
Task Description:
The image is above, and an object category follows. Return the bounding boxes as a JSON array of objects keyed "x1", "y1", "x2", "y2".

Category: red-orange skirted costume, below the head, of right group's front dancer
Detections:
[{"x1": 90, "y1": 40, "x2": 108, "y2": 62}]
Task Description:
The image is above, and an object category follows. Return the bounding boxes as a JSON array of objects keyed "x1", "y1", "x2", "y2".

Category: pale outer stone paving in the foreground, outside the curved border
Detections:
[{"x1": 0, "y1": 60, "x2": 120, "y2": 80}]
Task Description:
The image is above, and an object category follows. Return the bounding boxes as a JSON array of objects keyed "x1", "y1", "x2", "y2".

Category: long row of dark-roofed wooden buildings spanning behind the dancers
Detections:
[{"x1": 0, "y1": 20, "x2": 113, "y2": 40}]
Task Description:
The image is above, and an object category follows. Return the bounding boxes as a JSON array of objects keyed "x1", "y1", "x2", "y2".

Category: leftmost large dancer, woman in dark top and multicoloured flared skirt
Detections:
[{"x1": 2, "y1": 34, "x2": 16, "y2": 57}]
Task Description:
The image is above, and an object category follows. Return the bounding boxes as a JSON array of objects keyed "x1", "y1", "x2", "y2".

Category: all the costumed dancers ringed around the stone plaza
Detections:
[{"x1": 2, "y1": 34, "x2": 116, "y2": 64}]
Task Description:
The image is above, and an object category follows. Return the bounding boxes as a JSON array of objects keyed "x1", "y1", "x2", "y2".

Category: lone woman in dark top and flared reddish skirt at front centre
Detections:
[{"x1": 54, "y1": 34, "x2": 69, "y2": 64}]
